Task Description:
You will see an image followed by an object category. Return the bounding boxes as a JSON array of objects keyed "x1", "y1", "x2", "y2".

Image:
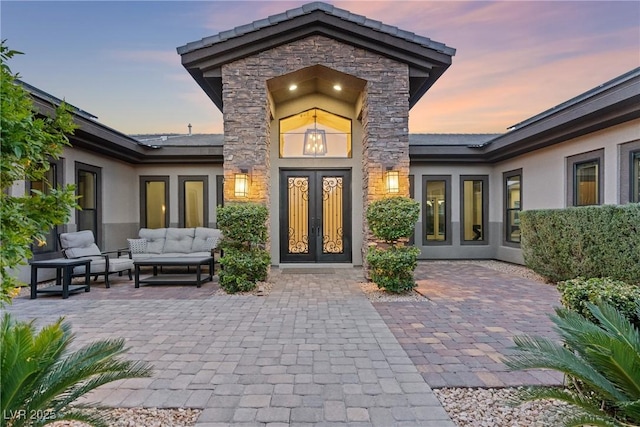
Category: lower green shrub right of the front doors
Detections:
[{"x1": 367, "y1": 246, "x2": 420, "y2": 293}]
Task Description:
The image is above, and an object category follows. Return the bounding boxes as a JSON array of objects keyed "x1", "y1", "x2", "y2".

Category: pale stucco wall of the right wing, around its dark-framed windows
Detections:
[{"x1": 411, "y1": 120, "x2": 640, "y2": 263}]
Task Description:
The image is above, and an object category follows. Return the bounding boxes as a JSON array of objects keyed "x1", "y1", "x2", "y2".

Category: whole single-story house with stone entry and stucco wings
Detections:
[{"x1": 12, "y1": 3, "x2": 640, "y2": 286}]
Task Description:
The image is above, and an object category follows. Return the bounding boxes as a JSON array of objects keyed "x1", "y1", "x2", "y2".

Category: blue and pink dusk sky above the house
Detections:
[{"x1": 0, "y1": 0, "x2": 640, "y2": 134}]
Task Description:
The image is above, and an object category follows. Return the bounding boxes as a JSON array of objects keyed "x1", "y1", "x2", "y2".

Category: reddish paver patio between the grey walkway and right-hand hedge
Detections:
[{"x1": 374, "y1": 262, "x2": 562, "y2": 387}]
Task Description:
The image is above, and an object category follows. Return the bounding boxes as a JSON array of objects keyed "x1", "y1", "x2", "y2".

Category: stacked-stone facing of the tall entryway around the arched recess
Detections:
[{"x1": 222, "y1": 36, "x2": 409, "y2": 260}]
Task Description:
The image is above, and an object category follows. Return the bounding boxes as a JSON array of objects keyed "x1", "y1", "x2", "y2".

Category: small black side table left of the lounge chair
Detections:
[{"x1": 29, "y1": 258, "x2": 91, "y2": 299}]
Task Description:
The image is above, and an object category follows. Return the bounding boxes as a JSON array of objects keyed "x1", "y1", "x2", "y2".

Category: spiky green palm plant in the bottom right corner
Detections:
[{"x1": 505, "y1": 302, "x2": 640, "y2": 426}]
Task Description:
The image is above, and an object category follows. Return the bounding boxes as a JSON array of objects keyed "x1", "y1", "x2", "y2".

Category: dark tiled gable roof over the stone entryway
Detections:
[{"x1": 177, "y1": 2, "x2": 455, "y2": 111}]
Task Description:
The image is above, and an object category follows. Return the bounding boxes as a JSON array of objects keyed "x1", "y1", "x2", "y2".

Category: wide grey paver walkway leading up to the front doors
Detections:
[{"x1": 8, "y1": 269, "x2": 454, "y2": 427}]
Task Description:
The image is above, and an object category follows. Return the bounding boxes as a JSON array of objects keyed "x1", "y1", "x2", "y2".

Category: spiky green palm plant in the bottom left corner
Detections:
[{"x1": 0, "y1": 313, "x2": 152, "y2": 427}]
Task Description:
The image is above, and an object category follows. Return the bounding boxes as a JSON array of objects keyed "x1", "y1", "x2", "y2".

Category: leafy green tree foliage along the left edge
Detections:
[{"x1": 0, "y1": 40, "x2": 76, "y2": 302}]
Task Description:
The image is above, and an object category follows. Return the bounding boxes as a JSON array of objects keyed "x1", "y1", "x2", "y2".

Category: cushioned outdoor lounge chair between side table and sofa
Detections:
[{"x1": 58, "y1": 230, "x2": 133, "y2": 288}]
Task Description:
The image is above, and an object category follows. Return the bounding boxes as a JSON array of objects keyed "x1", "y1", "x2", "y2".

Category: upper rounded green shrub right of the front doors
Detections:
[{"x1": 367, "y1": 197, "x2": 420, "y2": 242}]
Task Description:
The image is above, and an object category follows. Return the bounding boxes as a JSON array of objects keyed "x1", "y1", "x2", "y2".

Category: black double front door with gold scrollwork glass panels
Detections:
[{"x1": 280, "y1": 170, "x2": 351, "y2": 263}]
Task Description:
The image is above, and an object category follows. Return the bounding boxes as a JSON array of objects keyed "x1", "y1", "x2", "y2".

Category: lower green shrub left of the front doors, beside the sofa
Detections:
[{"x1": 218, "y1": 248, "x2": 271, "y2": 293}]
